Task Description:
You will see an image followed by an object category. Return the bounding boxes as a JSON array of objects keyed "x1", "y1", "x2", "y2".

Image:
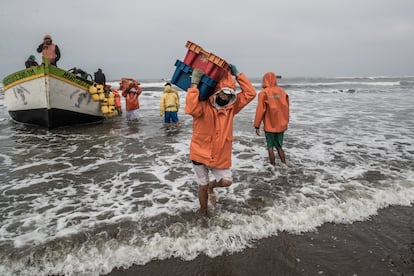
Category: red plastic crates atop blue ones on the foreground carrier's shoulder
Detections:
[{"x1": 184, "y1": 41, "x2": 230, "y2": 81}]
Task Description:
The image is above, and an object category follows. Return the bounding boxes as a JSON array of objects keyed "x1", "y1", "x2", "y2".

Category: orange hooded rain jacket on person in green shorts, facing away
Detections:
[{"x1": 254, "y1": 72, "x2": 289, "y2": 132}]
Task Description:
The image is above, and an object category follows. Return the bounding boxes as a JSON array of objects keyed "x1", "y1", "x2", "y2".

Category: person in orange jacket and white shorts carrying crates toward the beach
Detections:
[{"x1": 185, "y1": 65, "x2": 256, "y2": 215}]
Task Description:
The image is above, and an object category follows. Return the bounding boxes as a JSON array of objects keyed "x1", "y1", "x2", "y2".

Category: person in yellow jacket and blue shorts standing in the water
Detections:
[{"x1": 160, "y1": 82, "x2": 180, "y2": 128}]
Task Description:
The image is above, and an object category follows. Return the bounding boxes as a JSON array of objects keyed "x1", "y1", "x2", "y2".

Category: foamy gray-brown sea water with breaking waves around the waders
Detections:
[{"x1": 0, "y1": 76, "x2": 414, "y2": 275}]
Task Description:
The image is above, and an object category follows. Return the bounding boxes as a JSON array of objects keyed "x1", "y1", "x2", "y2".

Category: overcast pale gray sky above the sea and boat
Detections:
[{"x1": 0, "y1": 0, "x2": 414, "y2": 80}]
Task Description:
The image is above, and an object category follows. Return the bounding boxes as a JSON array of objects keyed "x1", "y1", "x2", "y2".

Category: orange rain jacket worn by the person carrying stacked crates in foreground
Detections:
[{"x1": 185, "y1": 72, "x2": 256, "y2": 169}]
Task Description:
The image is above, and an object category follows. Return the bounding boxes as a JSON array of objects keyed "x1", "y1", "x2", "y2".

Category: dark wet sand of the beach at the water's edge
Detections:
[{"x1": 108, "y1": 206, "x2": 414, "y2": 276}]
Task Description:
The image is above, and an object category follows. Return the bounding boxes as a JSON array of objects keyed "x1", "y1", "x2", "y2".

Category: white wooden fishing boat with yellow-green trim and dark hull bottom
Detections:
[{"x1": 2, "y1": 61, "x2": 106, "y2": 129}]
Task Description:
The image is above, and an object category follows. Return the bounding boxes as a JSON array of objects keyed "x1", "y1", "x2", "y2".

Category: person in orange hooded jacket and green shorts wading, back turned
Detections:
[{"x1": 254, "y1": 72, "x2": 289, "y2": 166}]
